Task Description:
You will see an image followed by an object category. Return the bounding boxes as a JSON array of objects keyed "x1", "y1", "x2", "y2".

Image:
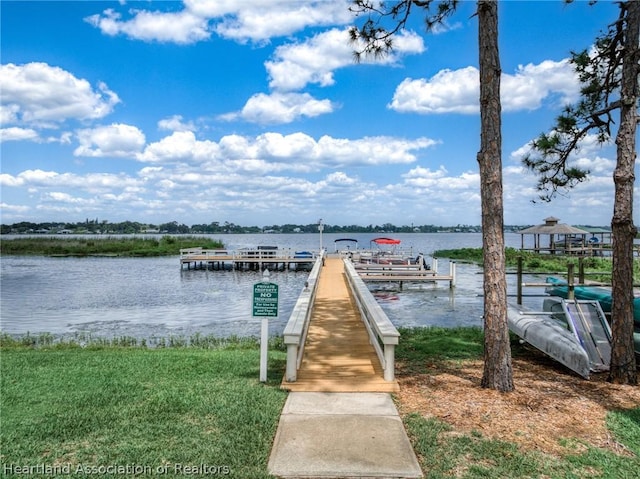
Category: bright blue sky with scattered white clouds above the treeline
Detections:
[{"x1": 0, "y1": 0, "x2": 640, "y2": 226}]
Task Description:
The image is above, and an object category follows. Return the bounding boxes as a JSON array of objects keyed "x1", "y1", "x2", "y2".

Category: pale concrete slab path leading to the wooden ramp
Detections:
[{"x1": 269, "y1": 392, "x2": 422, "y2": 478}]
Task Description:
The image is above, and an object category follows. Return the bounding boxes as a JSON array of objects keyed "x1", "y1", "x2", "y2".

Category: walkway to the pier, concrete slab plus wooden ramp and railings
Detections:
[{"x1": 268, "y1": 257, "x2": 423, "y2": 479}]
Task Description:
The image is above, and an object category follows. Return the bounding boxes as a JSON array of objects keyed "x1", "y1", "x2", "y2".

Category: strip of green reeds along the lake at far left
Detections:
[{"x1": 0, "y1": 236, "x2": 224, "y2": 257}]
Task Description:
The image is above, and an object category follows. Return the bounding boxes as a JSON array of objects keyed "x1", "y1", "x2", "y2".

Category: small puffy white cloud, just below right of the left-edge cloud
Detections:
[{"x1": 73, "y1": 124, "x2": 145, "y2": 158}]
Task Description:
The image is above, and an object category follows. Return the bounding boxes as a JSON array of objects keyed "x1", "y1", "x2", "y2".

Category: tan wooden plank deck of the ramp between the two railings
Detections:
[{"x1": 282, "y1": 258, "x2": 399, "y2": 392}]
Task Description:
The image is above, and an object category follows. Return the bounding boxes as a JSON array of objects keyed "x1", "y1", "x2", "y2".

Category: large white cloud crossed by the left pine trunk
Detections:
[{"x1": 389, "y1": 60, "x2": 579, "y2": 114}]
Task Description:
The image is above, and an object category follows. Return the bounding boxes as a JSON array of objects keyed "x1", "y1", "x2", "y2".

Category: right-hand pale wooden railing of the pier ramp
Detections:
[{"x1": 343, "y1": 259, "x2": 400, "y2": 381}]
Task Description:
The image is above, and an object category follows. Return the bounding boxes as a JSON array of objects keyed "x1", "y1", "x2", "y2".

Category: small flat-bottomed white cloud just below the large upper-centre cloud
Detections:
[{"x1": 220, "y1": 92, "x2": 334, "y2": 124}]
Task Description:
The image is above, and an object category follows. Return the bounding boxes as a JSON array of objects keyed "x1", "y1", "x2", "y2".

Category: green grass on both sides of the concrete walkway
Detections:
[{"x1": 0, "y1": 328, "x2": 640, "y2": 478}]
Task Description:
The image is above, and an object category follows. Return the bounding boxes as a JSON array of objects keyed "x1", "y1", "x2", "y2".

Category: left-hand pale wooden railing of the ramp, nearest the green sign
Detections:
[{"x1": 283, "y1": 252, "x2": 324, "y2": 382}]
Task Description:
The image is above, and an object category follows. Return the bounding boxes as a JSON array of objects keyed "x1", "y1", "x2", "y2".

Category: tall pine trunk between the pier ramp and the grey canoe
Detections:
[{"x1": 478, "y1": 0, "x2": 514, "y2": 391}]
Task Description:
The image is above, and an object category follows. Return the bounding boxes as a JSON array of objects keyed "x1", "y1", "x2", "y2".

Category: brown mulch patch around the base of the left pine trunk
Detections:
[{"x1": 398, "y1": 351, "x2": 640, "y2": 456}]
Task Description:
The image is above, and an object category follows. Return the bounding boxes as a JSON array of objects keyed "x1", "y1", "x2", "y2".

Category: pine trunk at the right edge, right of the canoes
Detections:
[{"x1": 609, "y1": 1, "x2": 640, "y2": 384}]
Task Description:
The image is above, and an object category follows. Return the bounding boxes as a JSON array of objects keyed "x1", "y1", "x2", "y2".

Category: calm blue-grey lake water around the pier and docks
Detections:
[{"x1": 0, "y1": 233, "x2": 541, "y2": 338}]
